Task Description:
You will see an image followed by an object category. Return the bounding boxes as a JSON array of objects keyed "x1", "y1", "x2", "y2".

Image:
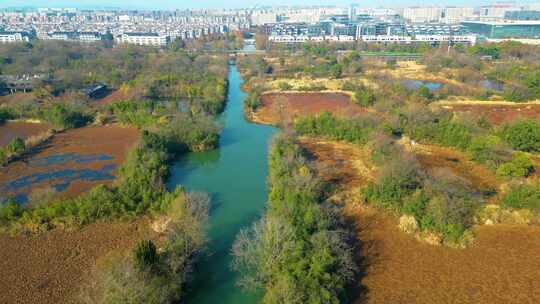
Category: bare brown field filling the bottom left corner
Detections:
[{"x1": 0, "y1": 220, "x2": 149, "y2": 304}]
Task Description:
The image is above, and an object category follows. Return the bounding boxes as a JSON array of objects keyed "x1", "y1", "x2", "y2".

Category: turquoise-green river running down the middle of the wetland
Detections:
[{"x1": 169, "y1": 65, "x2": 276, "y2": 304}]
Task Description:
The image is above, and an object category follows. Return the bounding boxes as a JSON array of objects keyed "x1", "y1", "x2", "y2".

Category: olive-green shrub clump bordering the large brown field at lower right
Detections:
[{"x1": 363, "y1": 150, "x2": 478, "y2": 245}]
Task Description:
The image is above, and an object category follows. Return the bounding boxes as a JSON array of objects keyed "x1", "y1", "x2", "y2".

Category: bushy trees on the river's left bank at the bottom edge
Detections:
[{"x1": 81, "y1": 190, "x2": 209, "y2": 303}]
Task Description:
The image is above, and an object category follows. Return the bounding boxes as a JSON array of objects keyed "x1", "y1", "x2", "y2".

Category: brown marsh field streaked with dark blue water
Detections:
[{"x1": 0, "y1": 125, "x2": 139, "y2": 203}]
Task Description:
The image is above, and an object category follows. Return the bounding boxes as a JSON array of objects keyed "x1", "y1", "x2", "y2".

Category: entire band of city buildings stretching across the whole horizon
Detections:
[{"x1": 0, "y1": 3, "x2": 540, "y2": 46}]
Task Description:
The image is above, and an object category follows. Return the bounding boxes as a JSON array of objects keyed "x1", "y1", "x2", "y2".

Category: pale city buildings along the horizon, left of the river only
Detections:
[{"x1": 0, "y1": 9, "x2": 250, "y2": 46}]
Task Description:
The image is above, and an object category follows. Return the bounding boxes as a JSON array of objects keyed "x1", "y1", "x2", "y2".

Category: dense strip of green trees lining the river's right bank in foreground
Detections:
[{"x1": 233, "y1": 135, "x2": 357, "y2": 303}]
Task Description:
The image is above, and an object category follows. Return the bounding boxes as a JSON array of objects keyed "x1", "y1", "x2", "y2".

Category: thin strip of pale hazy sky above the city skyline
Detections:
[{"x1": 0, "y1": 0, "x2": 540, "y2": 9}]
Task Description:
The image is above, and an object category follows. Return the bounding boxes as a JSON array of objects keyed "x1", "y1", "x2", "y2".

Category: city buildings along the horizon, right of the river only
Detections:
[{"x1": 260, "y1": 3, "x2": 540, "y2": 44}]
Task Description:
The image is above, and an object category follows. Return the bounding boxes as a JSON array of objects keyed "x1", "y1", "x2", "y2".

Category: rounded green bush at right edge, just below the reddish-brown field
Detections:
[{"x1": 501, "y1": 119, "x2": 540, "y2": 152}]
